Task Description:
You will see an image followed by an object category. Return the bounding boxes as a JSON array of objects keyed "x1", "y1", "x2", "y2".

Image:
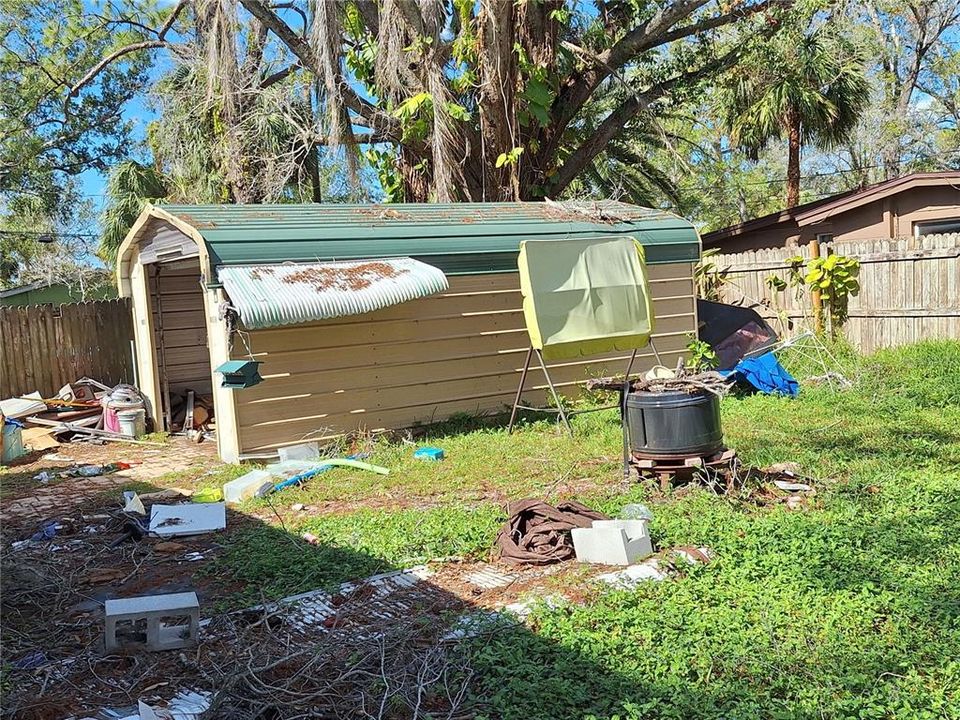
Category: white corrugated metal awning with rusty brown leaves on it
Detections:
[{"x1": 217, "y1": 257, "x2": 449, "y2": 330}]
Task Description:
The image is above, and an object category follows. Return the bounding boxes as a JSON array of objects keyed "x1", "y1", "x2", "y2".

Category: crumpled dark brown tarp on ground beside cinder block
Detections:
[{"x1": 497, "y1": 498, "x2": 609, "y2": 565}]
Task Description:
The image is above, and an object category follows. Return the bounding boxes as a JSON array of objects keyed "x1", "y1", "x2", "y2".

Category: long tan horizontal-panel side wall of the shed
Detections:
[{"x1": 234, "y1": 263, "x2": 697, "y2": 455}]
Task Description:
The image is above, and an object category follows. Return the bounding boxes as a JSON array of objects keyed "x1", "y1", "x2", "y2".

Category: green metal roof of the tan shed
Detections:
[{"x1": 159, "y1": 201, "x2": 700, "y2": 275}]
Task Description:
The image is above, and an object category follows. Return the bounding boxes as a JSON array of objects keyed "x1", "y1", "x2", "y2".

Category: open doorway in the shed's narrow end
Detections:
[{"x1": 147, "y1": 258, "x2": 213, "y2": 432}]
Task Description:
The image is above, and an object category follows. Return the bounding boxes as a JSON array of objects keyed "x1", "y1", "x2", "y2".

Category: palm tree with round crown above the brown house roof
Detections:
[{"x1": 719, "y1": 26, "x2": 870, "y2": 207}]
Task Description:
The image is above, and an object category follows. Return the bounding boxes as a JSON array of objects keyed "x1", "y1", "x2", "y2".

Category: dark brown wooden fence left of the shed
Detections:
[{"x1": 0, "y1": 299, "x2": 133, "y2": 398}]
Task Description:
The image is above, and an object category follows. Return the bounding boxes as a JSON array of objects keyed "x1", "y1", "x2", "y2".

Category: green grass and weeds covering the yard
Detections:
[{"x1": 210, "y1": 342, "x2": 960, "y2": 719}]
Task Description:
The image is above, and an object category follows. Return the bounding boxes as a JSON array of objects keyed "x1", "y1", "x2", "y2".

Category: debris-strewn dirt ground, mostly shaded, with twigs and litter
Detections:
[{"x1": 0, "y1": 439, "x2": 708, "y2": 719}]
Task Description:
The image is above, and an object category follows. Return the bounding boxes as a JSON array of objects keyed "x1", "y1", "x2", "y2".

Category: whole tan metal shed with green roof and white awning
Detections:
[{"x1": 117, "y1": 202, "x2": 700, "y2": 462}]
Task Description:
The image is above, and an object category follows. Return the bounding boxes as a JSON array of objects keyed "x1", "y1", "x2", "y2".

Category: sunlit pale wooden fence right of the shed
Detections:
[{"x1": 714, "y1": 233, "x2": 960, "y2": 352}]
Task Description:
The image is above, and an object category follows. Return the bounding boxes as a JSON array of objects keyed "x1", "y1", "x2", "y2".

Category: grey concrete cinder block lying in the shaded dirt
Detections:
[{"x1": 104, "y1": 592, "x2": 200, "y2": 652}]
